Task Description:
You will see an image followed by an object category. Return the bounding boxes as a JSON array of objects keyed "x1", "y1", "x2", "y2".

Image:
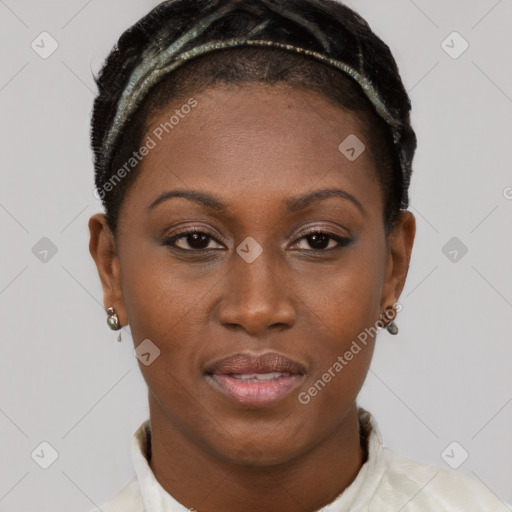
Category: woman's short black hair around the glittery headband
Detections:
[{"x1": 91, "y1": 0, "x2": 416, "y2": 236}]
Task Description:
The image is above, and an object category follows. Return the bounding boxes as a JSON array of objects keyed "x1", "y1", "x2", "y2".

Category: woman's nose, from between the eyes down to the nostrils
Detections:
[{"x1": 218, "y1": 247, "x2": 296, "y2": 336}]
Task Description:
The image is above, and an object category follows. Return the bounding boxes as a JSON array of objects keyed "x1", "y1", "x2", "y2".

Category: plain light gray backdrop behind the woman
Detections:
[{"x1": 0, "y1": 0, "x2": 512, "y2": 512}]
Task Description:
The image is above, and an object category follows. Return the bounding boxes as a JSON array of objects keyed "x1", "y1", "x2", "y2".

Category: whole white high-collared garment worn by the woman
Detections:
[{"x1": 96, "y1": 408, "x2": 510, "y2": 512}]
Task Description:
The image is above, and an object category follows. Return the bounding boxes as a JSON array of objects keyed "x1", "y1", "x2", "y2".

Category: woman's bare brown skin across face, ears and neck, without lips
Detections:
[{"x1": 89, "y1": 83, "x2": 415, "y2": 512}]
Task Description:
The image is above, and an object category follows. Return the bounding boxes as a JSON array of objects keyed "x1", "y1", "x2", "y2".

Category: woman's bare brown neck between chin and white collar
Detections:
[{"x1": 149, "y1": 393, "x2": 366, "y2": 512}]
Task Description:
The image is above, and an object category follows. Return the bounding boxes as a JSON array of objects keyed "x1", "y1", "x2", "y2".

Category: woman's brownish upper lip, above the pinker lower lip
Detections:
[{"x1": 206, "y1": 352, "x2": 306, "y2": 375}]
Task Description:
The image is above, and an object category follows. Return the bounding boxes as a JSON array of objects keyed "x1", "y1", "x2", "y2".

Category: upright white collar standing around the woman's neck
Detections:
[{"x1": 131, "y1": 408, "x2": 385, "y2": 512}]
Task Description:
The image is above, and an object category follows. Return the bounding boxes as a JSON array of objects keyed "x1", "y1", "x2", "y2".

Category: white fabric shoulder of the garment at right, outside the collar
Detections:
[{"x1": 369, "y1": 448, "x2": 508, "y2": 512}]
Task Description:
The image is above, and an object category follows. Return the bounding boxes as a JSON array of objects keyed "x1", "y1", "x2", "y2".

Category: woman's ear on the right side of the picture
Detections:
[{"x1": 380, "y1": 211, "x2": 416, "y2": 313}]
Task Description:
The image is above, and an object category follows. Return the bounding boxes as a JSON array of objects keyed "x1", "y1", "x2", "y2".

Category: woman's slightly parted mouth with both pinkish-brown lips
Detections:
[{"x1": 205, "y1": 352, "x2": 306, "y2": 408}]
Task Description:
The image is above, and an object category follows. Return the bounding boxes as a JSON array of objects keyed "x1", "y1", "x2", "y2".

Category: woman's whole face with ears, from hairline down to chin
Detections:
[{"x1": 90, "y1": 84, "x2": 414, "y2": 464}]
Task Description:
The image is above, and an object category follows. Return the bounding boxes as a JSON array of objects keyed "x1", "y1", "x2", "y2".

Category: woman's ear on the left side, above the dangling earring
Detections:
[{"x1": 89, "y1": 213, "x2": 128, "y2": 326}]
